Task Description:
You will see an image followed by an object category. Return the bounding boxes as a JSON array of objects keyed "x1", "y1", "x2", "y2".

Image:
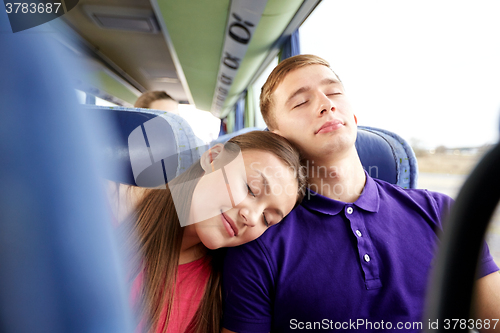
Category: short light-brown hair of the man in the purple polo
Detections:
[{"x1": 260, "y1": 54, "x2": 340, "y2": 131}]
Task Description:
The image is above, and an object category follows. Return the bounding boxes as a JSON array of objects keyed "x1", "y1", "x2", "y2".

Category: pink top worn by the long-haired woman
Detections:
[{"x1": 132, "y1": 257, "x2": 211, "y2": 333}]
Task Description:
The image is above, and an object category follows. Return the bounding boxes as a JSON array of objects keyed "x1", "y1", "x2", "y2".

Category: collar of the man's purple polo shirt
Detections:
[{"x1": 302, "y1": 171, "x2": 380, "y2": 215}]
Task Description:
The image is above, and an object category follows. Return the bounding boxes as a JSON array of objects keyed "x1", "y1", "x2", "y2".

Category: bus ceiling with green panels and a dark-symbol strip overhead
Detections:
[{"x1": 52, "y1": 0, "x2": 321, "y2": 118}]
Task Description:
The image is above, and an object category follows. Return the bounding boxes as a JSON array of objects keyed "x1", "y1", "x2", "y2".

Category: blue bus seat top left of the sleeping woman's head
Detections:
[{"x1": 85, "y1": 105, "x2": 208, "y2": 187}]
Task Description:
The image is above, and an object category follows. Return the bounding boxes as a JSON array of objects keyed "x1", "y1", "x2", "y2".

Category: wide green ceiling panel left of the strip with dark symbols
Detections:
[{"x1": 158, "y1": 0, "x2": 230, "y2": 110}]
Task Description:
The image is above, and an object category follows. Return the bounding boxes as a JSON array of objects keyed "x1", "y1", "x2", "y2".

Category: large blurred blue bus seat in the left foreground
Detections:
[{"x1": 0, "y1": 16, "x2": 135, "y2": 333}]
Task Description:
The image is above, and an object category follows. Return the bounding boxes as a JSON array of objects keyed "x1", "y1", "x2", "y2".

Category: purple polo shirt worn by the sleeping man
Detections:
[{"x1": 223, "y1": 175, "x2": 498, "y2": 332}]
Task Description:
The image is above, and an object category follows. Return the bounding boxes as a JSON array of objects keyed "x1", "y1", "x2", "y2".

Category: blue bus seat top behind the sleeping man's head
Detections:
[{"x1": 210, "y1": 126, "x2": 418, "y2": 188}]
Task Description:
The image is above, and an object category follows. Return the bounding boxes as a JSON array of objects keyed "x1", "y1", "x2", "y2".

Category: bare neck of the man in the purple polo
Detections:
[{"x1": 306, "y1": 148, "x2": 366, "y2": 202}]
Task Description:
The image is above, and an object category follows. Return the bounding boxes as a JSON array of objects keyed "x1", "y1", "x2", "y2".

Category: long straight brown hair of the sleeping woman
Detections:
[{"x1": 132, "y1": 131, "x2": 306, "y2": 333}]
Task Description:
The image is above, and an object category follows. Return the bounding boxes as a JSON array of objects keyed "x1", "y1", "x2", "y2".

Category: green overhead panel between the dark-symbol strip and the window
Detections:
[{"x1": 222, "y1": 0, "x2": 303, "y2": 115}]
